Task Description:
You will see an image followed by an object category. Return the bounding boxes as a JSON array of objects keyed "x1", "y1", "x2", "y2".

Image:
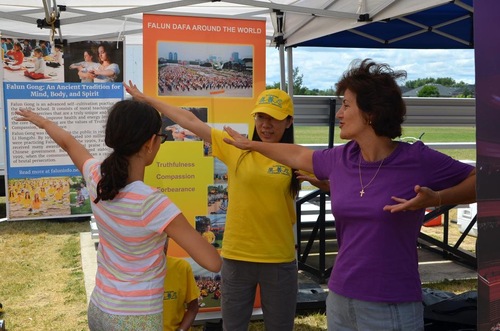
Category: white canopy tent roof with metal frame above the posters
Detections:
[{"x1": 0, "y1": 0, "x2": 466, "y2": 92}]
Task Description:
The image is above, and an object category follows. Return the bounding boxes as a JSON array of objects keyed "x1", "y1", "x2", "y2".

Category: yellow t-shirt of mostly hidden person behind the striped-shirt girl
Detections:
[{"x1": 163, "y1": 256, "x2": 200, "y2": 331}]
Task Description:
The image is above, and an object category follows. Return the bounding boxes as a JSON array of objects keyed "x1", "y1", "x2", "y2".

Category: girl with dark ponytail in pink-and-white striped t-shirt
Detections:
[{"x1": 16, "y1": 100, "x2": 222, "y2": 331}]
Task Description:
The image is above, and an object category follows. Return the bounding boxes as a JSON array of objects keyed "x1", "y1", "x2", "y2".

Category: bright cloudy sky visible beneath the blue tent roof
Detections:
[{"x1": 266, "y1": 47, "x2": 475, "y2": 90}]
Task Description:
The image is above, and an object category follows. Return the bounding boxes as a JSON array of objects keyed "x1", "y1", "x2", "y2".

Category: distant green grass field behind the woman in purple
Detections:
[{"x1": 295, "y1": 126, "x2": 476, "y2": 160}]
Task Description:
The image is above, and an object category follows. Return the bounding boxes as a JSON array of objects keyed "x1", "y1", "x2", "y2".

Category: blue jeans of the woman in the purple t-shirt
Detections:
[{"x1": 326, "y1": 291, "x2": 424, "y2": 331}]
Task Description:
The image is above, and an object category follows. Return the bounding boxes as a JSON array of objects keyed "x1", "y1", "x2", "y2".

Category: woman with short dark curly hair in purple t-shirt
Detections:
[{"x1": 225, "y1": 59, "x2": 476, "y2": 331}]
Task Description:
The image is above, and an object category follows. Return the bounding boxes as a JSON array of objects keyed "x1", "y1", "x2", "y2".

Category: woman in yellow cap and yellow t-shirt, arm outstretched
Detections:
[{"x1": 124, "y1": 82, "x2": 300, "y2": 331}]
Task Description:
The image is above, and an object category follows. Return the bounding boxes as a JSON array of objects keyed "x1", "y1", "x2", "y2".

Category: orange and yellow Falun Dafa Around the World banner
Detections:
[{"x1": 143, "y1": 15, "x2": 266, "y2": 311}]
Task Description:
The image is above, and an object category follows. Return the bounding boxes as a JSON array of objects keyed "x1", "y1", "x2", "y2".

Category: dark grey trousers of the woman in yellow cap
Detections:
[{"x1": 221, "y1": 259, "x2": 298, "y2": 331}]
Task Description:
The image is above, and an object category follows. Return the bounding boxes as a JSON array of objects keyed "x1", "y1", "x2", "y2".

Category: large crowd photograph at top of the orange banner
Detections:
[{"x1": 158, "y1": 41, "x2": 253, "y2": 98}]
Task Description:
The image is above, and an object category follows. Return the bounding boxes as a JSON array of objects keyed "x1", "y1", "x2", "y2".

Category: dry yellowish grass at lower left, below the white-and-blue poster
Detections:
[{"x1": 0, "y1": 219, "x2": 90, "y2": 331}]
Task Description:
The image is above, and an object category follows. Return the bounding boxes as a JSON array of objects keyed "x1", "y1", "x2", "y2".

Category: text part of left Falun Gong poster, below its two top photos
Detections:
[{"x1": 4, "y1": 82, "x2": 123, "y2": 220}]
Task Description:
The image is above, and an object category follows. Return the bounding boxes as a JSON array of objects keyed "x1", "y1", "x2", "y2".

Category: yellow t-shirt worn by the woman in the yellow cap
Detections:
[{"x1": 212, "y1": 129, "x2": 296, "y2": 263}]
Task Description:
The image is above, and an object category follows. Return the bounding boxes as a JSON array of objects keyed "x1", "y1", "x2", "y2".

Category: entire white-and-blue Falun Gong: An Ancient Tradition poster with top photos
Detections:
[{"x1": 1, "y1": 38, "x2": 124, "y2": 220}]
